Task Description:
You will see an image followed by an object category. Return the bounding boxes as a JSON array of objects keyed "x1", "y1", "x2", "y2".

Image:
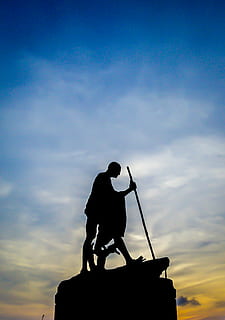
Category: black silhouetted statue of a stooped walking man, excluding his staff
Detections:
[{"x1": 81, "y1": 162, "x2": 139, "y2": 272}]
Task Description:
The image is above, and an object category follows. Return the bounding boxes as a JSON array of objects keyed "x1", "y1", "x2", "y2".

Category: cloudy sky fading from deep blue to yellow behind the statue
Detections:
[{"x1": 0, "y1": 0, "x2": 225, "y2": 320}]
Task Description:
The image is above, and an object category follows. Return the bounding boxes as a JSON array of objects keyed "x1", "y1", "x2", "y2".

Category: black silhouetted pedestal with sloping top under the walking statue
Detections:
[{"x1": 55, "y1": 258, "x2": 177, "y2": 320}]
